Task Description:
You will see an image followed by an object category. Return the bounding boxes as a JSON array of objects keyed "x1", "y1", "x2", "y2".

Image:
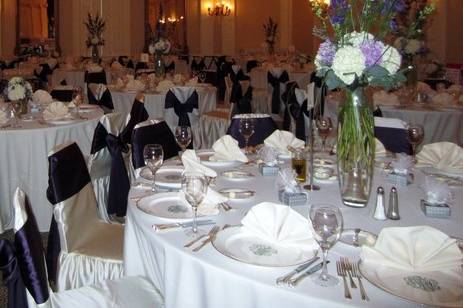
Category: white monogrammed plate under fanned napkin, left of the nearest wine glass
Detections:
[{"x1": 212, "y1": 226, "x2": 317, "y2": 267}]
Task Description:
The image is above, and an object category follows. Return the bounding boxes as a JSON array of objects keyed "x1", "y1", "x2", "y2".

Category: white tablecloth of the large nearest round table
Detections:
[{"x1": 124, "y1": 159, "x2": 463, "y2": 308}]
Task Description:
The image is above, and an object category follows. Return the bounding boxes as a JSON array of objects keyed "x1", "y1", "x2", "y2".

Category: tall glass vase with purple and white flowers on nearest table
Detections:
[{"x1": 312, "y1": 0, "x2": 405, "y2": 207}]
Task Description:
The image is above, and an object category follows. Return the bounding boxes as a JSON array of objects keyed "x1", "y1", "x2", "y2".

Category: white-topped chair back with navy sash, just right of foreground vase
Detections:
[{"x1": 375, "y1": 117, "x2": 412, "y2": 155}]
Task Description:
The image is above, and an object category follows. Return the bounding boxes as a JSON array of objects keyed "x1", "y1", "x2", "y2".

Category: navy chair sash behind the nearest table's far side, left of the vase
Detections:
[{"x1": 227, "y1": 117, "x2": 277, "y2": 148}]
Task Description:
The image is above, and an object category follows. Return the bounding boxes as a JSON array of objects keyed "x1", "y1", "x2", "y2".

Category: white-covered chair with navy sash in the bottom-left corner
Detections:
[{"x1": 0, "y1": 188, "x2": 164, "y2": 308}]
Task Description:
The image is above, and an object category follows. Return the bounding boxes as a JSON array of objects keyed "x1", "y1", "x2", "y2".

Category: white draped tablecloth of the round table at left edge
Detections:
[{"x1": 0, "y1": 109, "x2": 103, "y2": 232}]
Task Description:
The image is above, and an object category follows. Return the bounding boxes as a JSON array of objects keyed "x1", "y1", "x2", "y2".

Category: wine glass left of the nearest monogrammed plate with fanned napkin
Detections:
[{"x1": 182, "y1": 173, "x2": 208, "y2": 237}]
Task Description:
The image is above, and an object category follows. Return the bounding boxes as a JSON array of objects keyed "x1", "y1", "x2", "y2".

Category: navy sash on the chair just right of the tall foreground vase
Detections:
[{"x1": 375, "y1": 126, "x2": 412, "y2": 155}]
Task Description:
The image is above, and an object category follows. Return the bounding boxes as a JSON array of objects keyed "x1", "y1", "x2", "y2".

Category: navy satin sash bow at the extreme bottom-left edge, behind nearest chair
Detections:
[{"x1": 0, "y1": 239, "x2": 28, "y2": 308}]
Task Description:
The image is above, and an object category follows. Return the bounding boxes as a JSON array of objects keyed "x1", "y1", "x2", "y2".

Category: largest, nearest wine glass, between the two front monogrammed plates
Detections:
[{"x1": 309, "y1": 204, "x2": 343, "y2": 287}]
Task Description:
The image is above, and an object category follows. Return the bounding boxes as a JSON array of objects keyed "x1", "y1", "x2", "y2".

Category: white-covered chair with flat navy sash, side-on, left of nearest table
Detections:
[{"x1": 47, "y1": 143, "x2": 124, "y2": 291}]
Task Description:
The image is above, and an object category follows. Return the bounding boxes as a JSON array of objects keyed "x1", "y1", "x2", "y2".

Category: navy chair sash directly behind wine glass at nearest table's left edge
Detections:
[{"x1": 132, "y1": 121, "x2": 180, "y2": 169}]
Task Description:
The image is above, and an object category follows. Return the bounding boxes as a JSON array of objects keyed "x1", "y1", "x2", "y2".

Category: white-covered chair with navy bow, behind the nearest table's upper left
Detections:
[{"x1": 164, "y1": 87, "x2": 201, "y2": 148}]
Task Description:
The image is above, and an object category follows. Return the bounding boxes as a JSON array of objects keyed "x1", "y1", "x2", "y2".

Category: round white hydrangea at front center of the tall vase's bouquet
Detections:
[{"x1": 331, "y1": 46, "x2": 366, "y2": 85}]
